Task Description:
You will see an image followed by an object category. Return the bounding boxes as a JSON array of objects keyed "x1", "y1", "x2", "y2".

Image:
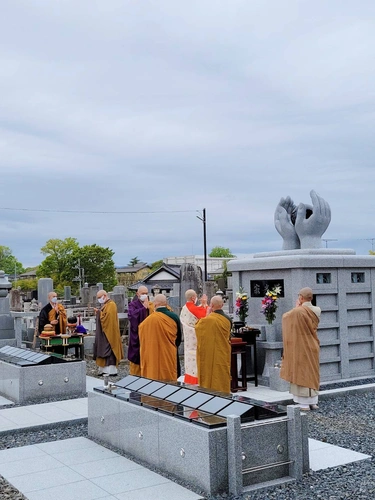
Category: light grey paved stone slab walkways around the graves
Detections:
[{"x1": 0, "y1": 377, "x2": 370, "y2": 500}]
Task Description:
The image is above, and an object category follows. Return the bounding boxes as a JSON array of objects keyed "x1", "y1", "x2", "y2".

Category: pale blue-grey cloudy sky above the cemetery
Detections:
[{"x1": 0, "y1": 0, "x2": 375, "y2": 267}]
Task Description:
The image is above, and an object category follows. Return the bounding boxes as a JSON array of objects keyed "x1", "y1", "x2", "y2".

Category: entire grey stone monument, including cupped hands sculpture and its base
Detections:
[{"x1": 228, "y1": 191, "x2": 375, "y2": 387}]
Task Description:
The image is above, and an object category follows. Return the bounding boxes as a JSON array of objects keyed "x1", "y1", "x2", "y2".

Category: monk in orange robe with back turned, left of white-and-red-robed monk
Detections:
[{"x1": 139, "y1": 294, "x2": 181, "y2": 382}]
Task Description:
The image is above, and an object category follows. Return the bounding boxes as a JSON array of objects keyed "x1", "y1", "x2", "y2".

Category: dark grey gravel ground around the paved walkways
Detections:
[{"x1": 0, "y1": 361, "x2": 375, "y2": 500}]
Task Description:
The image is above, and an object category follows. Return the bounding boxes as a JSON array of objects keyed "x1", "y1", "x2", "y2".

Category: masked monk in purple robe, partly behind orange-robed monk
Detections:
[{"x1": 128, "y1": 285, "x2": 154, "y2": 376}]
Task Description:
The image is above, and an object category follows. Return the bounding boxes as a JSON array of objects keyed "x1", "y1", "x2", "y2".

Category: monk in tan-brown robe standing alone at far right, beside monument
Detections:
[{"x1": 280, "y1": 287, "x2": 321, "y2": 410}]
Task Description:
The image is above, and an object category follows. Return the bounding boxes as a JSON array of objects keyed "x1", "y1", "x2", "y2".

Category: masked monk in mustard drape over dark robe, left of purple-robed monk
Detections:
[{"x1": 94, "y1": 290, "x2": 124, "y2": 375}]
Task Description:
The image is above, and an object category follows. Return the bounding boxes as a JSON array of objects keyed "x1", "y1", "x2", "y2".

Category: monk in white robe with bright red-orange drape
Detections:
[{"x1": 180, "y1": 290, "x2": 208, "y2": 385}]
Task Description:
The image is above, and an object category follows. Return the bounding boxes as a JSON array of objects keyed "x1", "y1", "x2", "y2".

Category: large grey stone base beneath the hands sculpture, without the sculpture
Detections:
[{"x1": 228, "y1": 252, "x2": 375, "y2": 385}]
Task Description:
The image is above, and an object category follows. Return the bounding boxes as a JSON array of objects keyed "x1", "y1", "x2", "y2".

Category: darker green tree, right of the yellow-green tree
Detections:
[{"x1": 76, "y1": 244, "x2": 117, "y2": 290}]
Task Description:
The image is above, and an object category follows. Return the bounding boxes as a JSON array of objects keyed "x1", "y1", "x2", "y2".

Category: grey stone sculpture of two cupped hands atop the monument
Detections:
[{"x1": 275, "y1": 191, "x2": 331, "y2": 250}]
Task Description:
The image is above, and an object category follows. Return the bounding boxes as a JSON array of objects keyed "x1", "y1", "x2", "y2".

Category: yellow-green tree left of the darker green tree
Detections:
[{"x1": 37, "y1": 238, "x2": 79, "y2": 289}]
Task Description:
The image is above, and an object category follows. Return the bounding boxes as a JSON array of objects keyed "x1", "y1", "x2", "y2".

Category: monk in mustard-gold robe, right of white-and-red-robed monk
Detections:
[{"x1": 195, "y1": 295, "x2": 232, "y2": 393}]
